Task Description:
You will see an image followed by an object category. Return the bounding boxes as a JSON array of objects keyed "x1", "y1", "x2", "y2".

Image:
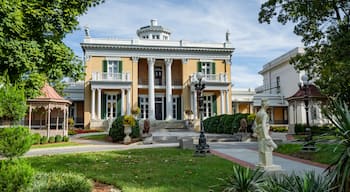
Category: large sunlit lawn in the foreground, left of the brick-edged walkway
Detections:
[{"x1": 28, "y1": 148, "x2": 233, "y2": 192}]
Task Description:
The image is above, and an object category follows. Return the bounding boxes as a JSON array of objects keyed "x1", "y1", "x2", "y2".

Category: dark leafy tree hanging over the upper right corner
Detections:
[{"x1": 259, "y1": 0, "x2": 350, "y2": 103}]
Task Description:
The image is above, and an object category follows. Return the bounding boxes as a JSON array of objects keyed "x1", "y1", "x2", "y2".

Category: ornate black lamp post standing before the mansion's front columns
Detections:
[{"x1": 194, "y1": 72, "x2": 210, "y2": 156}]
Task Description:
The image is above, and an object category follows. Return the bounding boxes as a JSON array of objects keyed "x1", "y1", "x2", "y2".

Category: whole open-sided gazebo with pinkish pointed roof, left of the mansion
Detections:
[{"x1": 27, "y1": 83, "x2": 71, "y2": 137}]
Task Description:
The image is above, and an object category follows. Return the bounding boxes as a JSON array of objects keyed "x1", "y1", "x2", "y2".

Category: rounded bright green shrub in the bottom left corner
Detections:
[{"x1": 0, "y1": 159, "x2": 34, "y2": 192}]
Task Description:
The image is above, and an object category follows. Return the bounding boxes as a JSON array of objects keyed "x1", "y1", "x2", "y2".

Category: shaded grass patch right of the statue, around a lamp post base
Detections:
[{"x1": 275, "y1": 143, "x2": 343, "y2": 165}]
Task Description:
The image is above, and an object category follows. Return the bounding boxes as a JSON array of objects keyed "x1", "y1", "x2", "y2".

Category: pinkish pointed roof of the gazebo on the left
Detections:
[{"x1": 28, "y1": 83, "x2": 71, "y2": 104}]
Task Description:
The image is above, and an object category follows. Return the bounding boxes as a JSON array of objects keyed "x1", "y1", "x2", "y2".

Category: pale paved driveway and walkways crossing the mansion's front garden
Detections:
[{"x1": 19, "y1": 132, "x2": 326, "y2": 174}]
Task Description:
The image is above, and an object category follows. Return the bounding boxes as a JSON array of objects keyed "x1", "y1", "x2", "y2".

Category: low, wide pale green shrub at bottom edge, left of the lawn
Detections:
[{"x1": 28, "y1": 172, "x2": 92, "y2": 192}]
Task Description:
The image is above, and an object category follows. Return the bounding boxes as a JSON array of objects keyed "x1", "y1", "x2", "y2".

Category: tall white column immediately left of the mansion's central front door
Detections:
[{"x1": 147, "y1": 58, "x2": 155, "y2": 120}]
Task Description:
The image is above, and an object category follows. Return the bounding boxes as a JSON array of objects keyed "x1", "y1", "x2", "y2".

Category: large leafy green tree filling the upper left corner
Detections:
[{"x1": 0, "y1": 0, "x2": 104, "y2": 97}]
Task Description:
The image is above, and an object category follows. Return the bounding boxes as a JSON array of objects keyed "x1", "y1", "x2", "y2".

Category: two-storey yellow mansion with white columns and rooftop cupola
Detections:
[{"x1": 66, "y1": 20, "x2": 234, "y2": 128}]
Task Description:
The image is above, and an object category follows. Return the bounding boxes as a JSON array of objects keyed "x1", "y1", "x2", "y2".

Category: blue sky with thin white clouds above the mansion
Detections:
[{"x1": 64, "y1": 0, "x2": 302, "y2": 89}]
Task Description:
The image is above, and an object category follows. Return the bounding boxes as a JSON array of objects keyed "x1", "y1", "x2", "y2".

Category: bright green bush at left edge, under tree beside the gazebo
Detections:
[{"x1": 0, "y1": 85, "x2": 27, "y2": 122}]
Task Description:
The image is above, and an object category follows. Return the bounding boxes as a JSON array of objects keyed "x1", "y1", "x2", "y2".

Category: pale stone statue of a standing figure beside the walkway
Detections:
[{"x1": 254, "y1": 100, "x2": 281, "y2": 171}]
